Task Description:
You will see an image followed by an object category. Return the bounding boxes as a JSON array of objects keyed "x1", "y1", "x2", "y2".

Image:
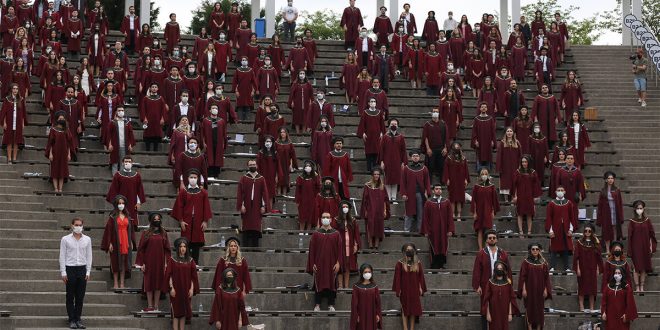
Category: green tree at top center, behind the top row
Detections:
[{"x1": 296, "y1": 10, "x2": 344, "y2": 40}]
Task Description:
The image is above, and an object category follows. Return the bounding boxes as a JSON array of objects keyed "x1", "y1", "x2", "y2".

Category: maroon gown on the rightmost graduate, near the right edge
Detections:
[{"x1": 628, "y1": 218, "x2": 658, "y2": 273}]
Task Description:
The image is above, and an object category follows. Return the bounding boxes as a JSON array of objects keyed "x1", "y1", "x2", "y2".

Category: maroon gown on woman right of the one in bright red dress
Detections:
[{"x1": 135, "y1": 229, "x2": 172, "y2": 292}]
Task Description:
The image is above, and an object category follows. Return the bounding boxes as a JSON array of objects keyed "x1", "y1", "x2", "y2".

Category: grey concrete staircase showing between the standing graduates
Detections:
[{"x1": 0, "y1": 34, "x2": 660, "y2": 329}]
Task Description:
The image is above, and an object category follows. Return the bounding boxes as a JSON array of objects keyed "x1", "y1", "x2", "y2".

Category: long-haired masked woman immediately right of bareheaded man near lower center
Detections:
[{"x1": 331, "y1": 201, "x2": 362, "y2": 289}]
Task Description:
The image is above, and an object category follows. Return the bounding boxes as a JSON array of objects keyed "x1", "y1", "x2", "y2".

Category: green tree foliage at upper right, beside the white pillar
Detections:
[{"x1": 521, "y1": 0, "x2": 604, "y2": 45}]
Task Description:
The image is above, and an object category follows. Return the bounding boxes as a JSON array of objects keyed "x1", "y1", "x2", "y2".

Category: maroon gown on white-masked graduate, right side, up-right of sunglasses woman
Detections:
[{"x1": 545, "y1": 199, "x2": 577, "y2": 253}]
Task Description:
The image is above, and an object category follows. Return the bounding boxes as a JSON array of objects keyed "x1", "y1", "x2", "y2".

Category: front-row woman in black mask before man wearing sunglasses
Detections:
[{"x1": 481, "y1": 261, "x2": 520, "y2": 330}]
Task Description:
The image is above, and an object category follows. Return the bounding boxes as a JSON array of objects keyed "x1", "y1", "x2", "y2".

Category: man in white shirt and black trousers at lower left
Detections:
[{"x1": 60, "y1": 218, "x2": 92, "y2": 329}]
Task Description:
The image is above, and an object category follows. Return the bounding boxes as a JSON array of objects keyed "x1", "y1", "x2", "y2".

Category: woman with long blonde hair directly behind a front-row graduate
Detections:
[{"x1": 211, "y1": 237, "x2": 252, "y2": 296}]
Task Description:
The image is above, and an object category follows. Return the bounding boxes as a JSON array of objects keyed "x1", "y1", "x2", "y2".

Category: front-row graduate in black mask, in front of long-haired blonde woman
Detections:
[{"x1": 209, "y1": 268, "x2": 250, "y2": 330}]
